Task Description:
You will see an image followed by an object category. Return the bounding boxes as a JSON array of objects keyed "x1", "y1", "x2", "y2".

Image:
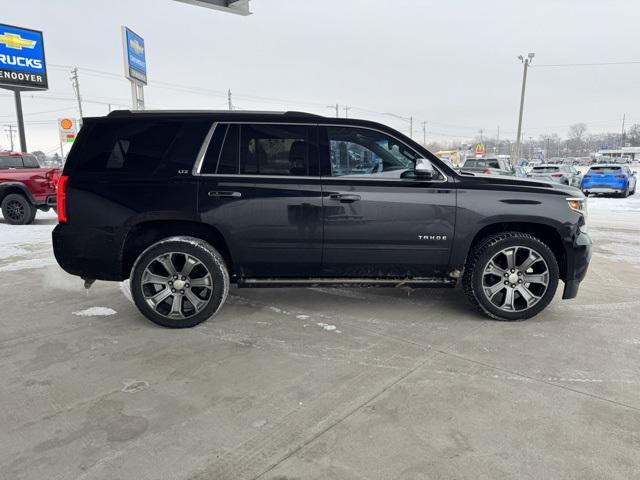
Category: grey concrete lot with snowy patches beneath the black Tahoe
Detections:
[{"x1": 0, "y1": 195, "x2": 640, "y2": 480}]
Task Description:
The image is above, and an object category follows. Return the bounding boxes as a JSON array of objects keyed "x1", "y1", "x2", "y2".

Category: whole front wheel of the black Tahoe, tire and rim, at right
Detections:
[{"x1": 463, "y1": 232, "x2": 560, "y2": 320}]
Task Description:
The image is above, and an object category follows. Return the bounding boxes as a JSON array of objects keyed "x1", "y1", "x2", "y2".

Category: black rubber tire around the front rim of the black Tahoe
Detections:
[{"x1": 462, "y1": 232, "x2": 560, "y2": 321}]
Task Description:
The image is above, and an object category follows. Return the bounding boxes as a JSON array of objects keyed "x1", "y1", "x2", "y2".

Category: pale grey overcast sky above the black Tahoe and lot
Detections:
[{"x1": 0, "y1": 0, "x2": 640, "y2": 153}]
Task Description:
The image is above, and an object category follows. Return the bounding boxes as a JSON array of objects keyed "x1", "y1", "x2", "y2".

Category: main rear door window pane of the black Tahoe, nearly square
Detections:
[{"x1": 240, "y1": 125, "x2": 309, "y2": 176}]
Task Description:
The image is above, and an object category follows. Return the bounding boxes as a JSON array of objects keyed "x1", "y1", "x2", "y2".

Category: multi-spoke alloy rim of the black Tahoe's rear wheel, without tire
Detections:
[{"x1": 140, "y1": 252, "x2": 213, "y2": 319}]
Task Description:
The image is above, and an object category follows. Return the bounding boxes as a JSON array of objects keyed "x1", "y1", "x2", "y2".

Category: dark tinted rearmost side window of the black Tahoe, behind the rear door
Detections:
[{"x1": 73, "y1": 119, "x2": 211, "y2": 176}]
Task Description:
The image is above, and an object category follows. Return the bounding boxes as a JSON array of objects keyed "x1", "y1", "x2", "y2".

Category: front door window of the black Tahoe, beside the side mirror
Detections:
[{"x1": 327, "y1": 127, "x2": 418, "y2": 178}]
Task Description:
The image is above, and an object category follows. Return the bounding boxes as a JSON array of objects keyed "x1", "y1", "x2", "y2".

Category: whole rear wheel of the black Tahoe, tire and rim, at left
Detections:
[{"x1": 131, "y1": 237, "x2": 229, "y2": 328}]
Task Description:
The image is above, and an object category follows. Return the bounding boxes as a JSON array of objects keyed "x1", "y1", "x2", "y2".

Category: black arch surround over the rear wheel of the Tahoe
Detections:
[{"x1": 121, "y1": 220, "x2": 233, "y2": 278}]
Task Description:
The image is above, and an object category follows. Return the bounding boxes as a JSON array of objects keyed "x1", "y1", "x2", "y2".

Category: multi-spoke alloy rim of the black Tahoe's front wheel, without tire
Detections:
[{"x1": 482, "y1": 246, "x2": 549, "y2": 312}]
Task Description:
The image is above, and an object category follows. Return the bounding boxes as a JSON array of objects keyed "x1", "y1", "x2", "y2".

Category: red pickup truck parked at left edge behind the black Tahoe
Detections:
[{"x1": 0, "y1": 152, "x2": 61, "y2": 225}]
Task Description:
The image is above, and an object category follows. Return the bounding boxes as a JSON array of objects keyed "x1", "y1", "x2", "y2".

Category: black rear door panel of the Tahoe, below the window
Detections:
[{"x1": 199, "y1": 176, "x2": 322, "y2": 277}]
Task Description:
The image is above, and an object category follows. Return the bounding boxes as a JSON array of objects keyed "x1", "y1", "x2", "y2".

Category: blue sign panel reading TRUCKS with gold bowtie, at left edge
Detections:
[{"x1": 0, "y1": 24, "x2": 48, "y2": 90}]
